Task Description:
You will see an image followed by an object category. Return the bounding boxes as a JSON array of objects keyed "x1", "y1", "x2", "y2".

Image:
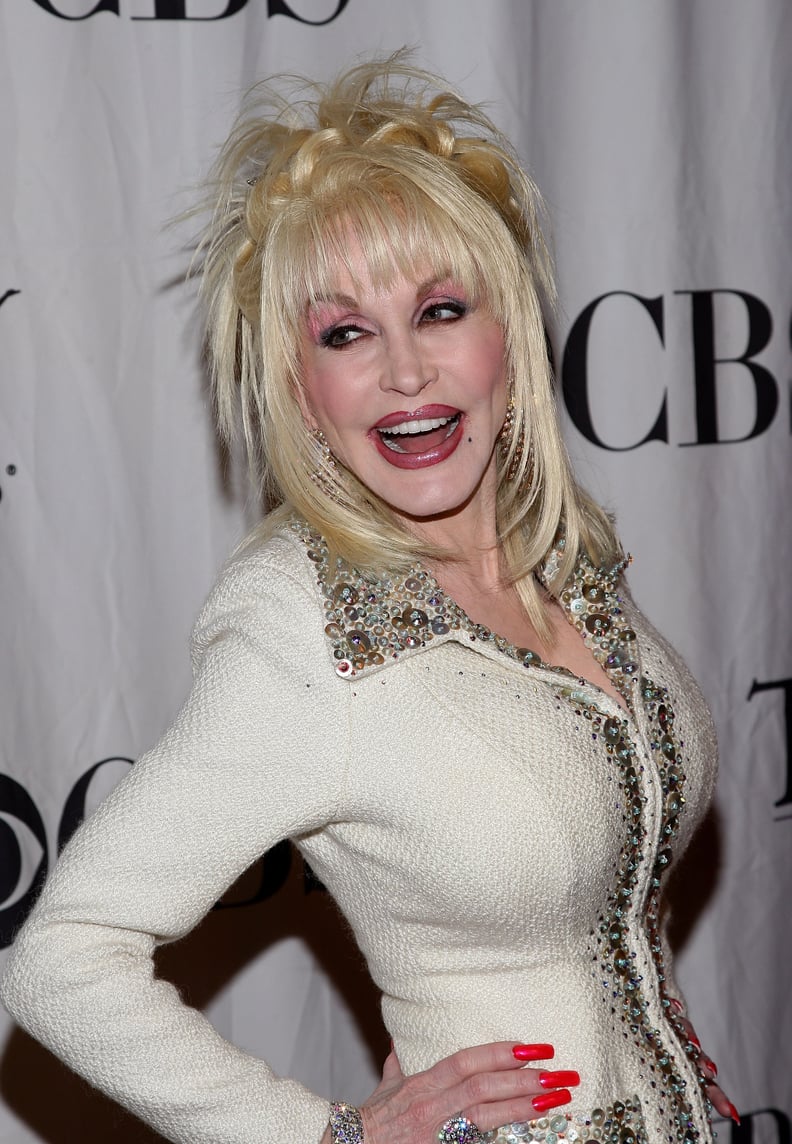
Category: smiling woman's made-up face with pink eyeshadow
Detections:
[{"x1": 302, "y1": 244, "x2": 507, "y2": 533}]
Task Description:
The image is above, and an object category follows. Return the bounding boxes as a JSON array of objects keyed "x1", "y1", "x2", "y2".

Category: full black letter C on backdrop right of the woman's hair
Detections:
[{"x1": 561, "y1": 289, "x2": 668, "y2": 452}]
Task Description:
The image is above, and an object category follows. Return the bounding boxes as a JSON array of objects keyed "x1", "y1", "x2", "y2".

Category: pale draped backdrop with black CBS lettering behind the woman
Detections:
[{"x1": 0, "y1": 0, "x2": 792, "y2": 1144}]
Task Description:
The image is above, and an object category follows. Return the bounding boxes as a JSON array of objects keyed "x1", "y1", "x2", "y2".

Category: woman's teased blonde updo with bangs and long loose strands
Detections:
[{"x1": 199, "y1": 53, "x2": 619, "y2": 635}]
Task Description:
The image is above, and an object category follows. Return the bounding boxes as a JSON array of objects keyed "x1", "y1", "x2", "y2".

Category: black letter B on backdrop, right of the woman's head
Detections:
[{"x1": 674, "y1": 289, "x2": 778, "y2": 445}]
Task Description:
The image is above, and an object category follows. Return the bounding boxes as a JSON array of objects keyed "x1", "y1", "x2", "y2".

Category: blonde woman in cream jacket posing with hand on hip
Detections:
[{"x1": 5, "y1": 57, "x2": 734, "y2": 1144}]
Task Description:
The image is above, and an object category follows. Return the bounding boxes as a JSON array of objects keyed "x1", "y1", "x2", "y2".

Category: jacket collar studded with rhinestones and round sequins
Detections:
[{"x1": 290, "y1": 521, "x2": 639, "y2": 699}]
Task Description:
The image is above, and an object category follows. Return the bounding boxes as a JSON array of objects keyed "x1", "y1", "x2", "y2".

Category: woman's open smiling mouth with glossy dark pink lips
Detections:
[{"x1": 371, "y1": 405, "x2": 462, "y2": 469}]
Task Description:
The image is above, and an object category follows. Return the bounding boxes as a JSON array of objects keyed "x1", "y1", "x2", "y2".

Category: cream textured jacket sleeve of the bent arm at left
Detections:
[{"x1": 2, "y1": 554, "x2": 348, "y2": 1144}]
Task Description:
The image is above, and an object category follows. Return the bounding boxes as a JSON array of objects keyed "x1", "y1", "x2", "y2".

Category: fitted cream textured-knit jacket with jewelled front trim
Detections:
[{"x1": 3, "y1": 531, "x2": 715, "y2": 1144}]
